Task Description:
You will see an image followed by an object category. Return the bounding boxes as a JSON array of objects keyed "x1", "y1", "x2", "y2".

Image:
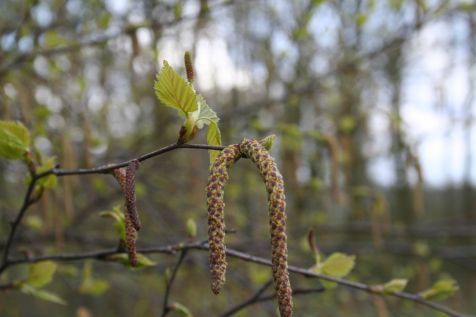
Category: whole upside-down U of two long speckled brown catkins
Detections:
[{"x1": 207, "y1": 139, "x2": 293, "y2": 317}]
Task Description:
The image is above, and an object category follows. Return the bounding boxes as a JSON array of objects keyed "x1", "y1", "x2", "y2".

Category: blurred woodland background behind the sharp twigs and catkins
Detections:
[{"x1": 0, "y1": 0, "x2": 476, "y2": 317}]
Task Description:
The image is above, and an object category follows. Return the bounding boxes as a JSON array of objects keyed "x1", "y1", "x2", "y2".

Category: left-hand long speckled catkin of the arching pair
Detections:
[{"x1": 207, "y1": 144, "x2": 241, "y2": 294}]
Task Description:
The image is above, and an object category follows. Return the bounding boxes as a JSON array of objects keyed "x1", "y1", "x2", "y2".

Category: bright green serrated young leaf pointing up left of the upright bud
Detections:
[{"x1": 154, "y1": 61, "x2": 198, "y2": 114}]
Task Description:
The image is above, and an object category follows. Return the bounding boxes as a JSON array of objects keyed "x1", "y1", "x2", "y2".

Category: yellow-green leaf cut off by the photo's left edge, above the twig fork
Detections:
[{"x1": 0, "y1": 121, "x2": 30, "y2": 160}]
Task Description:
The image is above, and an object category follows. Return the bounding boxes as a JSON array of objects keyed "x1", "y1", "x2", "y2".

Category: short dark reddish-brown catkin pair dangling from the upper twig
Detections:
[{"x1": 113, "y1": 161, "x2": 140, "y2": 266}]
